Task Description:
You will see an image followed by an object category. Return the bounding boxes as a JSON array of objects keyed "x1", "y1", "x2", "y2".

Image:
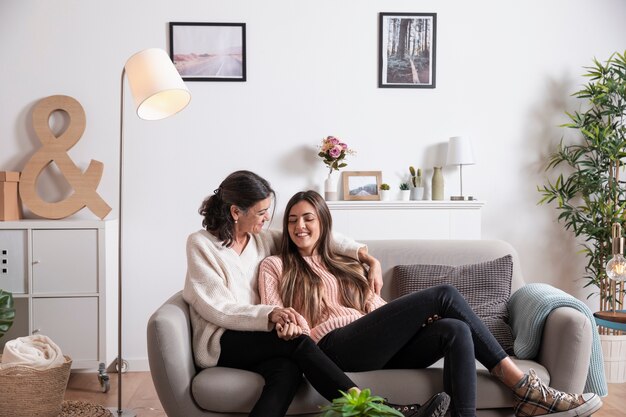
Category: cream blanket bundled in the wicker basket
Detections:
[{"x1": 0, "y1": 334, "x2": 65, "y2": 369}]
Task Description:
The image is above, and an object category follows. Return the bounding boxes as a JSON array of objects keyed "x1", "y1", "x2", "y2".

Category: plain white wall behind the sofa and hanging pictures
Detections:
[{"x1": 0, "y1": 0, "x2": 626, "y2": 369}]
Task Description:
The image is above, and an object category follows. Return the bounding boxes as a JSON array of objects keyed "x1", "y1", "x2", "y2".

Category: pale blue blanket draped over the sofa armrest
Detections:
[{"x1": 508, "y1": 284, "x2": 608, "y2": 397}]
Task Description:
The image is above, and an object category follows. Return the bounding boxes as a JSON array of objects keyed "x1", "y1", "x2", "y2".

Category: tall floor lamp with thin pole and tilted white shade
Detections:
[{"x1": 111, "y1": 48, "x2": 191, "y2": 417}]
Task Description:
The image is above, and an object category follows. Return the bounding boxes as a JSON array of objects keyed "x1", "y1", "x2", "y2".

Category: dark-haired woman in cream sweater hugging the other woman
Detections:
[{"x1": 183, "y1": 171, "x2": 446, "y2": 417}]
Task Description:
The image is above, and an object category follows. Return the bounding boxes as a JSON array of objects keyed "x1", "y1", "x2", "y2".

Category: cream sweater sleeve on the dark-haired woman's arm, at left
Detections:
[{"x1": 183, "y1": 234, "x2": 274, "y2": 331}]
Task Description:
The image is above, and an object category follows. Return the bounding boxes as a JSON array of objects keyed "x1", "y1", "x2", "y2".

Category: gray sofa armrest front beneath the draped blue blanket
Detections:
[{"x1": 537, "y1": 307, "x2": 593, "y2": 393}]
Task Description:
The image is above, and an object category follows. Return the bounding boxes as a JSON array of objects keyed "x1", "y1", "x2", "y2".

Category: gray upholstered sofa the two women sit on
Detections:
[{"x1": 148, "y1": 240, "x2": 592, "y2": 417}]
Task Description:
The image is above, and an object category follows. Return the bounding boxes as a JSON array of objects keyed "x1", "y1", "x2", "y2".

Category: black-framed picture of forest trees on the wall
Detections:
[{"x1": 378, "y1": 13, "x2": 437, "y2": 88}]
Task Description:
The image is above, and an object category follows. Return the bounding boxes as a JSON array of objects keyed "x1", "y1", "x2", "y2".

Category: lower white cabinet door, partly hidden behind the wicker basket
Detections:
[{"x1": 33, "y1": 297, "x2": 99, "y2": 367}]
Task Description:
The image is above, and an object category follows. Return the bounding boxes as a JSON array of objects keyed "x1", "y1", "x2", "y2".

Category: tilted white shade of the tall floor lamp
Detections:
[{"x1": 124, "y1": 48, "x2": 191, "y2": 120}]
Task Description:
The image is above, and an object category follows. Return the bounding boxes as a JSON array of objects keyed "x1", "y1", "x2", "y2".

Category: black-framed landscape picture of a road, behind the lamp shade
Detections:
[{"x1": 170, "y1": 22, "x2": 246, "y2": 81}]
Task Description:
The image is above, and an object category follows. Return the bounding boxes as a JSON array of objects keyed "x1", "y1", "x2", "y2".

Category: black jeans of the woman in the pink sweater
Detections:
[{"x1": 318, "y1": 285, "x2": 507, "y2": 417}]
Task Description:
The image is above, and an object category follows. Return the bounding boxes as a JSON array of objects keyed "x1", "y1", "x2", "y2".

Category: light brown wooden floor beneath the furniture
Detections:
[{"x1": 65, "y1": 372, "x2": 626, "y2": 417}]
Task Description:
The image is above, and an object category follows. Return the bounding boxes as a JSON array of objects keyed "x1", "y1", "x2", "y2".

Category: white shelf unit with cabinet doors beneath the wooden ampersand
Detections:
[{"x1": 0, "y1": 220, "x2": 117, "y2": 369}]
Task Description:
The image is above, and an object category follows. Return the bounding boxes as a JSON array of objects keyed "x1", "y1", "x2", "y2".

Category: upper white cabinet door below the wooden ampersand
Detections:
[{"x1": 32, "y1": 229, "x2": 98, "y2": 294}]
